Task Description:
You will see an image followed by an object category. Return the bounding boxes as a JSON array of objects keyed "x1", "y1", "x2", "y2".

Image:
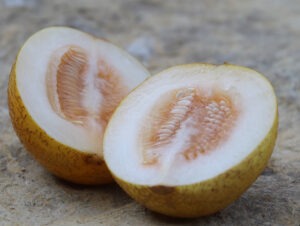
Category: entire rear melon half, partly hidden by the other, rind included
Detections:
[{"x1": 8, "y1": 27, "x2": 149, "y2": 184}]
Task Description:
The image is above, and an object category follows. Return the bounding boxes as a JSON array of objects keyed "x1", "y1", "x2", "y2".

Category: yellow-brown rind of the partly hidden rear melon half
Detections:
[{"x1": 8, "y1": 65, "x2": 113, "y2": 185}]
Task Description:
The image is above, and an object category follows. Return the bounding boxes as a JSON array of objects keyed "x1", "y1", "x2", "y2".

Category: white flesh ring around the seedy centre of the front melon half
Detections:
[{"x1": 104, "y1": 64, "x2": 277, "y2": 186}]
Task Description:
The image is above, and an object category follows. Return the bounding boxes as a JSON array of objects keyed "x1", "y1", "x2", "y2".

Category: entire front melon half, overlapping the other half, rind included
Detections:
[{"x1": 104, "y1": 64, "x2": 278, "y2": 217}]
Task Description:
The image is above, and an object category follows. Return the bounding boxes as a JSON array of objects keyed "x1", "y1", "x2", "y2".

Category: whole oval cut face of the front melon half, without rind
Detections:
[{"x1": 104, "y1": 64, "x2": 277, "y2": 186}]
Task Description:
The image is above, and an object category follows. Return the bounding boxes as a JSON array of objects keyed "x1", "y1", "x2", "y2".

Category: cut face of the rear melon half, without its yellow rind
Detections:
[{"x1": 16, "y1": 27, "x2": 149, "y2": 156}]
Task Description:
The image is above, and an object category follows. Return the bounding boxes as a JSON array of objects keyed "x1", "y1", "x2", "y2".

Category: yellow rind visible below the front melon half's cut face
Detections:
[{"x1": 113, "y1": 115, "x2": 278, "y2": 218}]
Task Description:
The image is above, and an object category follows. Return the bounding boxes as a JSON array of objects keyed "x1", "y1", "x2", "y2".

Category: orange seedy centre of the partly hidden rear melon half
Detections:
[{"x1": 46, "y1": 46, "x2": 129, "y2": 132}]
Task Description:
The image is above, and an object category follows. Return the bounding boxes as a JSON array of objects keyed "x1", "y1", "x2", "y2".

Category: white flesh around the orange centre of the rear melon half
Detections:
[{"x1": 15, "y1": 27, "x2": 149, "y2": 156}]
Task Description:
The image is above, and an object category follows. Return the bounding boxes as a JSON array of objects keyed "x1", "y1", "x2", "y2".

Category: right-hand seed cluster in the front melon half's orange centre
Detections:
[{"x1": 182, "y1": 95, "x2": 237, "y2": 160}]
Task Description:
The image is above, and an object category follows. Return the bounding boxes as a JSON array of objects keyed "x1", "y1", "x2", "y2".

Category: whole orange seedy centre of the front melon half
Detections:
[{"x1": 142, "y1": 87, "x2": 238, "y2": 165}]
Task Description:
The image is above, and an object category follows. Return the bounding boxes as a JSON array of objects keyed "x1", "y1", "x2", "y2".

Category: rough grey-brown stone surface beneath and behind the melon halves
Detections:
[{"x1": 0, "y1": 0, "x2": 300, "y2": 226}]
